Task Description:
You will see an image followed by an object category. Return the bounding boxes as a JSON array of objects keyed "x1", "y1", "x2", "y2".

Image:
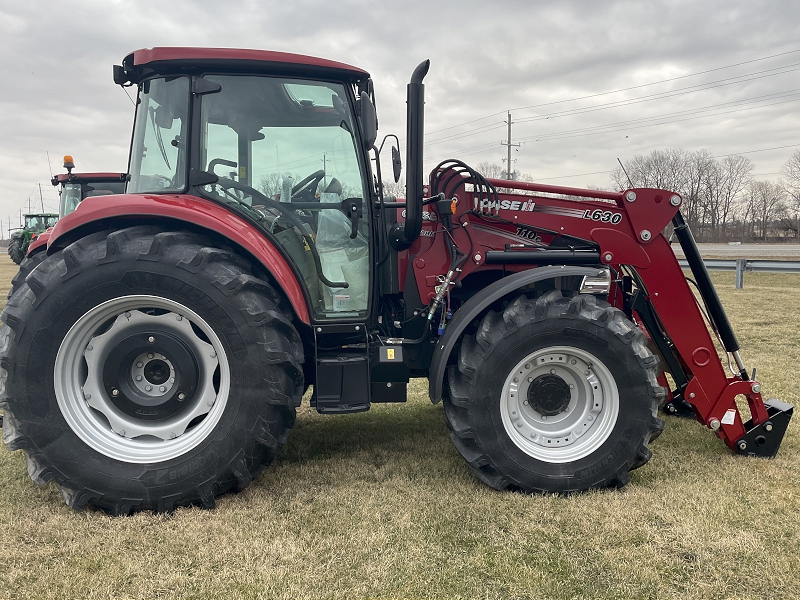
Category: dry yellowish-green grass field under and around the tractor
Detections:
[{"x1": 0, "y1": 259, "x2": 800, "y2": 599}]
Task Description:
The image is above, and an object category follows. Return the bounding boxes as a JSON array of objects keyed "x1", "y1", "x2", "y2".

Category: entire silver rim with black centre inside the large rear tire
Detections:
[{"x1": 54, "y1": 296, "x2": 230, "y2": 463}]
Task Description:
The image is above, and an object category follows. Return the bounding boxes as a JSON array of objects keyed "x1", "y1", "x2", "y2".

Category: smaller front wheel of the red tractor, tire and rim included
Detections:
[{"x1": 445, "y1": 292, "x2": 665, "y2": 493}]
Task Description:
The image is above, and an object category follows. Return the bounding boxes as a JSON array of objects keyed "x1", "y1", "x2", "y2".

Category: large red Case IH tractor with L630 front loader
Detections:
[{"x1": 0, "y1": 48, "x2": 793, "y2": 514}]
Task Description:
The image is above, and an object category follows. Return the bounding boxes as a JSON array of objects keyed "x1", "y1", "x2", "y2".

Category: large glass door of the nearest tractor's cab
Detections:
[{"x1": 201, "y1": 75, "x2": 369, "y2": 317}]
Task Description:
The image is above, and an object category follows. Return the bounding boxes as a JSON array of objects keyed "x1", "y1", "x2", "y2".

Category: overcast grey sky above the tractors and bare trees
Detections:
[{"x1": 0, "y1": 0, "x2": 800, "y2": 226}]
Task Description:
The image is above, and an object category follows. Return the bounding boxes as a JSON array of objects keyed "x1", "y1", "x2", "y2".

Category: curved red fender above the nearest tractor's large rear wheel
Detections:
[{"x1": 47, "y1": 194, "x2": 311, "y2": 324}]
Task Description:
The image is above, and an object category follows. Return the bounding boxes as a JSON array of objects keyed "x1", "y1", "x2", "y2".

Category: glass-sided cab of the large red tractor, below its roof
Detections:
[{"x1": 121, "y1": 54, "x2": 371, "y2": 321}]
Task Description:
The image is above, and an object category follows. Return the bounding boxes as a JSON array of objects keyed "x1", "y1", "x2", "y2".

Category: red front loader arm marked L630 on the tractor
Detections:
[{"x1": 414, "y1": 171, "x2": 793, "y2": 456}]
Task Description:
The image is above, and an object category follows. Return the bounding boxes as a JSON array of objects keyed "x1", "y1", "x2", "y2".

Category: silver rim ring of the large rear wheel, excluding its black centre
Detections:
[{"x1": 53, "y1": 295, "x2": 230, "y2": 463}]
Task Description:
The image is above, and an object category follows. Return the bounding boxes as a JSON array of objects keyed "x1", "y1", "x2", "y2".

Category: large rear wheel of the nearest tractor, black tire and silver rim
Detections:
[{"x1": 0, "y1": 227, "x2": 303, "y2": 514}]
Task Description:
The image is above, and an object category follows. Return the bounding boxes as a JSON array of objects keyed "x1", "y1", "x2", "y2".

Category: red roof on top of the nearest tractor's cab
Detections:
[{"x1": 114, "y1": 47, "x2": 369, "y2": 84}]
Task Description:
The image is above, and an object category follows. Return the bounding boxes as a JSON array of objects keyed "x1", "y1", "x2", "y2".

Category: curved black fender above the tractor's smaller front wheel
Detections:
[{"x1": 428, "y1": 267, "x2": 598, "y2": 404}]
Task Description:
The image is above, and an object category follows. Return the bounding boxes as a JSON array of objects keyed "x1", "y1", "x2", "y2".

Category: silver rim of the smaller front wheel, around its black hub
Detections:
[{"x1": 500, "y1": 346, "x2": 619, "y2": 463}]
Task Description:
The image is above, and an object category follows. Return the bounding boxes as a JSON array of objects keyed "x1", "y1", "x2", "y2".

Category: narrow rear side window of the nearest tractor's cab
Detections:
[{"x1": 128, "y1": 77, "x2": 189, "y2": 193}]
